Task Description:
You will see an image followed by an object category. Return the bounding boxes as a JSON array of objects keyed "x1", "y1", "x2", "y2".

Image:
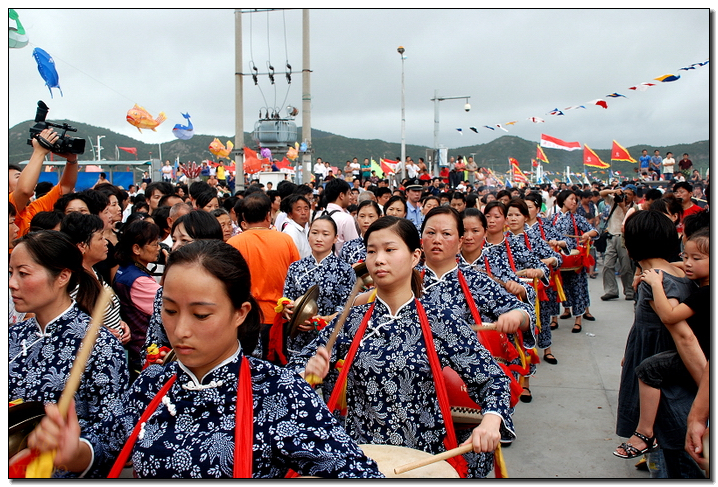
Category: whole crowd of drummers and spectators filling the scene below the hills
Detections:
[{"x1": 9, "y1": 129, "x2": 710, "y2": 478}]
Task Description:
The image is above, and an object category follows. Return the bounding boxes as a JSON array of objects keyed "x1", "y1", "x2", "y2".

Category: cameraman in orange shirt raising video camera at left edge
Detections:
[{"x1": 9, "y1": 128, "x2": 78, "y2": 237}]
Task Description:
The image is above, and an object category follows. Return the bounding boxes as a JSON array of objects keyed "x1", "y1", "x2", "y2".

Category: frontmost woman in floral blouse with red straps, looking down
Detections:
[{"x1": 22, "y1": 240, "x2": 381, "y2": 478}]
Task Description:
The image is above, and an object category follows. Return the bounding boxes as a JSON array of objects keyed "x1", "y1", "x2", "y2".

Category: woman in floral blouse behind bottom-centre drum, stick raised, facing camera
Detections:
[{"x1": 290, "y1": 217, "x2": 522, "y2": 475}]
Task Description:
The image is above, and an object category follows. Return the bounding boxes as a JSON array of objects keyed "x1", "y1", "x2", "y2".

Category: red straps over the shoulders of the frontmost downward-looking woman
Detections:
[{"x1": 107, "y1": 357, "x2": 254, "y2": 479}]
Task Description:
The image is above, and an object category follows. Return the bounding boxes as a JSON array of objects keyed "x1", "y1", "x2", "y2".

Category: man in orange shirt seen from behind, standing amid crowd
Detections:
[{"x1": 227, "y1": 193, "x2": 300, "y2": 359}]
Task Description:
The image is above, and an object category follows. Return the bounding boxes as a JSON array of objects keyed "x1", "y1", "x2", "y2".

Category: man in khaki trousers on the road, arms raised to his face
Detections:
[{"x1": 599, "y1": 184, "x2": 636, "y2": 301}]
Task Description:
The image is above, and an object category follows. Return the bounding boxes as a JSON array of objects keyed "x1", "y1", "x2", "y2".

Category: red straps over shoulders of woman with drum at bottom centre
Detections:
[{"x1": 327, "y1": 298, "x2": 468, "y2": 478}]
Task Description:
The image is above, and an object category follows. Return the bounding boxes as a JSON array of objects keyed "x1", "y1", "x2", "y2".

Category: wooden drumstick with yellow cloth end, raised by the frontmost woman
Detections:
[{"x1": 26, "y1": 287, "x2": 112, "y2": 478}]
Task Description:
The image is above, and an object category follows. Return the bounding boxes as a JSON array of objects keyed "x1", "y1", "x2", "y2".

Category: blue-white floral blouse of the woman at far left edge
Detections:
[{"x1": 8, "y1": 301, "x2": 129, "y2": 477}]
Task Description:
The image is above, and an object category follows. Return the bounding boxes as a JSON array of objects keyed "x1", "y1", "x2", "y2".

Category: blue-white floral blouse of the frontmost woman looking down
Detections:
[{"x1": 83, "y1": 348, "x2": 382, "y2": 478}]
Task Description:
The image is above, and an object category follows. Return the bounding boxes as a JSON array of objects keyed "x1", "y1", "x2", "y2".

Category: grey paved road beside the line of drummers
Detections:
[{"x1": 503, "y1": 267, "x2": 649, "y2": 479}]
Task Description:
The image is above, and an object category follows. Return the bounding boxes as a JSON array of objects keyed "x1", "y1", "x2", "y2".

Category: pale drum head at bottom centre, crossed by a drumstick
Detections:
[{"x1": 359, "y1": 445, "x2": 459, "y2": 479}]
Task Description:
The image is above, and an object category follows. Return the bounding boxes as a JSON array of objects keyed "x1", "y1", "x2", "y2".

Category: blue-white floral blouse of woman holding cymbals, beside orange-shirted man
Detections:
[{"x1": 283, "y1": 255, "x2": 356, "y2": 355}]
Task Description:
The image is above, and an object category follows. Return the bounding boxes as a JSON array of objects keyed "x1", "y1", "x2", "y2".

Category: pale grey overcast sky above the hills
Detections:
[{"x1": 8, "y1": 8, "x2": 710, "y2": 157}]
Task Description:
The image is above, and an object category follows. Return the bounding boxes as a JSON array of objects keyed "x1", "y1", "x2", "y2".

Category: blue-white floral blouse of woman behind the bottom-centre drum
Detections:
[{"x1": 287, "y1": 297, "x2": 515, "y2": 476}]
